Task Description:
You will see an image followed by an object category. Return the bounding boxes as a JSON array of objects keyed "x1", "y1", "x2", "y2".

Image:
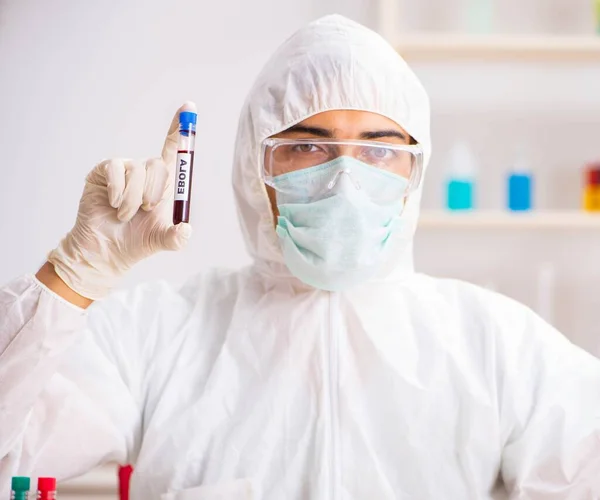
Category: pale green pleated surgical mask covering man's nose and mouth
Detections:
[{"x1": 274, "y1": 156, "x2": 408, "y2": 291}]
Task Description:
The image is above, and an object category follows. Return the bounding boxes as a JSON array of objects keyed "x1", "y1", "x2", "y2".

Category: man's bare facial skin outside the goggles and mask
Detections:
[{"x1": 266, "y1": 109, "x2": 413, "y2": 220}]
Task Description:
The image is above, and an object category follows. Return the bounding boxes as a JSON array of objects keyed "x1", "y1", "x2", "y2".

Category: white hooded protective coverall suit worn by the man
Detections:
[{"x1": 0, "y1": 16, "x2": 600, "y2": 500}]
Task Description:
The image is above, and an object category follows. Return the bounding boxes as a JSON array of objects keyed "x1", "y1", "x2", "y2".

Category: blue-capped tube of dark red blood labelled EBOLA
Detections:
[{"x1": 173, "y1": 111, "x2": 197, "y2": 224}]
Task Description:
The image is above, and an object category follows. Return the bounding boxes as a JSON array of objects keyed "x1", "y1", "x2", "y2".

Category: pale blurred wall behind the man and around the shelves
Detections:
[{"x1": 0, "y1": 0, "x2": 600, "y2": 354}]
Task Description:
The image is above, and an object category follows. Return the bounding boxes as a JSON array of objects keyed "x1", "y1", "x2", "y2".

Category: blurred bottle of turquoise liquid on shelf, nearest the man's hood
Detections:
[{"x1": 446, "y1": 143, "x2": 476, "y2": 211}]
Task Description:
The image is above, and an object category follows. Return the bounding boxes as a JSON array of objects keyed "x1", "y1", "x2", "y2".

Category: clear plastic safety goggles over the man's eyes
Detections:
[{"x1": 261, "y1": 138, "x2": 423, "y2": 200}]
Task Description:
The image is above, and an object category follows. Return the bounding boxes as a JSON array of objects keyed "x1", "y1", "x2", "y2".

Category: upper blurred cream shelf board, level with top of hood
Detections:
[{"x1": 395, "y1": 33, "x2": 600, "y2": 61}]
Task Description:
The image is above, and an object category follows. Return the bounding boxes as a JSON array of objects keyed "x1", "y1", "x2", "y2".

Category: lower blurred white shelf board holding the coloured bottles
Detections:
[{"x1": 419, "y1": 210, "x2": 600, "y2": 229}]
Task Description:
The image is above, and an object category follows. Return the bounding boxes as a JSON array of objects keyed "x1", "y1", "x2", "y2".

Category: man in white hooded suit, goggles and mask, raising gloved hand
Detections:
[{"x1": 0, "y1": 16, "x2": 600, "y2": 500}]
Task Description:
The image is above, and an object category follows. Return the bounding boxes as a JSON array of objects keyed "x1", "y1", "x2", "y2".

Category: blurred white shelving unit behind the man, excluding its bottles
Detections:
[{"x1": 394, "y1": 0, "x2": 600, "y2": 355}]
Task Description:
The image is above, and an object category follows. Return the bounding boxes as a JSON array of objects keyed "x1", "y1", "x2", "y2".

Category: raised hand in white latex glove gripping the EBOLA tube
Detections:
[{"x1": 48, "y1": 102, "x2": 196, "y2": 300}]
